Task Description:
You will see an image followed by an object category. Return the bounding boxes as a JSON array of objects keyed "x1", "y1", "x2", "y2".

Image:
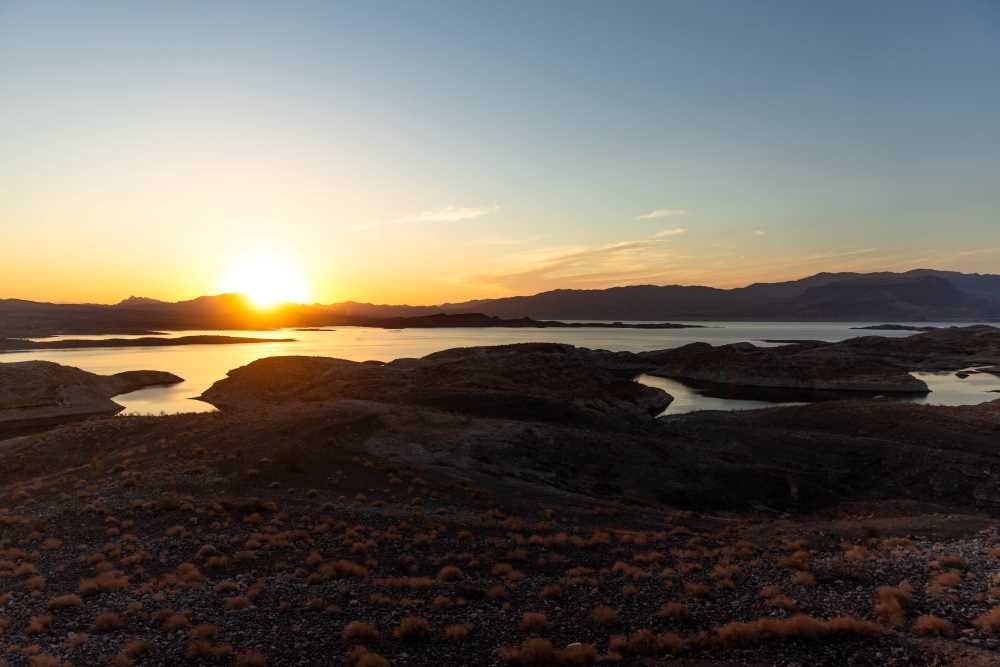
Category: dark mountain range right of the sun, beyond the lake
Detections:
[{"x1": 346, "y1": 269, "x2": 1000, "y2": 322}]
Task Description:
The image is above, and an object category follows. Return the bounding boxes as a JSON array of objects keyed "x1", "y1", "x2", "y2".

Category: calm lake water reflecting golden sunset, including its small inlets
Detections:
[{"x1": 0, "y1": 322, "x2": 1000, "y2": 414}]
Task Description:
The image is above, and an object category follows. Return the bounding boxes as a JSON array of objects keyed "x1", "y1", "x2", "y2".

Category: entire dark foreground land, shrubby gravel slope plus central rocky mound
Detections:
[{"x1": 0, "y1": 346, "x2": 1000, "y2": 667}]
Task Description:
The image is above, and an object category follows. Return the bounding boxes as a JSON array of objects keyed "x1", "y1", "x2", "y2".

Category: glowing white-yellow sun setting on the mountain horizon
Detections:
[{"x1": 218, "y1": 251, "x2": 309, "y2": 308}]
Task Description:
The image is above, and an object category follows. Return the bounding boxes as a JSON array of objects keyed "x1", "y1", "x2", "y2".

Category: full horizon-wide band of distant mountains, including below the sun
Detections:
[{"x1": 0, "y1": 269, "x2": 1000, "y2": 337}]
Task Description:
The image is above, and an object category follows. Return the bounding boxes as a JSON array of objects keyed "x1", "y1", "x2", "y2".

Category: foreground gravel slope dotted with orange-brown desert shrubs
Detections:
[{"x1": 0, "y1": 419, "x2": 1000, "y2": 667}]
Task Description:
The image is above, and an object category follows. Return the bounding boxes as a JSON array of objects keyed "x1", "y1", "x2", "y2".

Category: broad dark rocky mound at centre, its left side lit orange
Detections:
[{"x1": 199, "y1": 343, "x2": 672, "y2": 422}]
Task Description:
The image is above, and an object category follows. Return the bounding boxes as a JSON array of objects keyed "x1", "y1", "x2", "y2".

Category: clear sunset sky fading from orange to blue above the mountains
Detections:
[{"x1": 0, "y1": 0, "x2": 1000, "y2": 304}]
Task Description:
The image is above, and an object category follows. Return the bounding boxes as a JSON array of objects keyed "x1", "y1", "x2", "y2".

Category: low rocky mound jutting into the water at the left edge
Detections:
[{"x1": 0, "y1": 361, "x2": 183, "y2": 430}]
